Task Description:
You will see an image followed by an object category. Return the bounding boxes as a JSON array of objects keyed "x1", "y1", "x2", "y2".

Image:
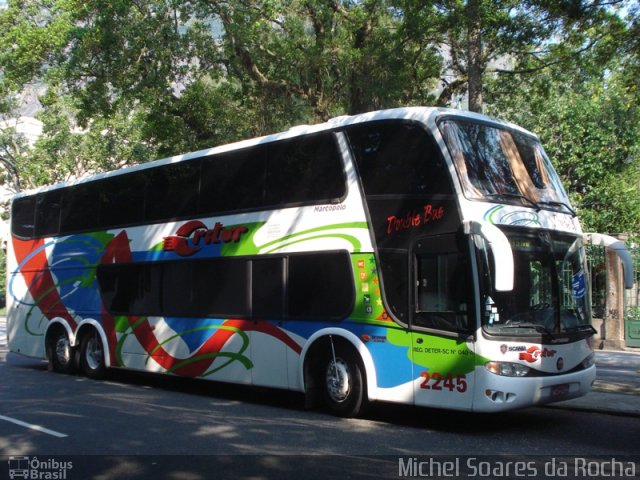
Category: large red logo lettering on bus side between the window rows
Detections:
[{"x1": 162, "y1": 220, "x2": 249, "y2": 257}]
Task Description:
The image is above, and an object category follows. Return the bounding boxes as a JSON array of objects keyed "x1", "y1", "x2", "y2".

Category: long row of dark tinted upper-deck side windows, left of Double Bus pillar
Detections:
[{"x1": 14, "y1": 133, "x2": 346, "y2": 237}]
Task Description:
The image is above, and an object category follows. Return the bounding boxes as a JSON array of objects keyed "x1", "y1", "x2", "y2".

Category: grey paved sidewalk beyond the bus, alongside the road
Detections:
[{"x1": 0, "y1": 316, "x2": 640, "y2": 417}]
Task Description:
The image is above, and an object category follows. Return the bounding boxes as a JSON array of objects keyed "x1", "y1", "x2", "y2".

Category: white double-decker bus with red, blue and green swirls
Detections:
[{"x1": 8, "y1": 107, "x2": 629, "y2": 416}]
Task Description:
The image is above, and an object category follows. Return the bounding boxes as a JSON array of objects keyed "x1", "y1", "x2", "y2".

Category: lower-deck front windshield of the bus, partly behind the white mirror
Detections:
[{"x1": 476, "y1": 231, "x2": 593, "y2": 336}]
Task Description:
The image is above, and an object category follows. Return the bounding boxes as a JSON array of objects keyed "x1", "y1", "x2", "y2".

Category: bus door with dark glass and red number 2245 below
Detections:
[{"x1": 411, "y1": 234, "x2": 475, "y2": 409}]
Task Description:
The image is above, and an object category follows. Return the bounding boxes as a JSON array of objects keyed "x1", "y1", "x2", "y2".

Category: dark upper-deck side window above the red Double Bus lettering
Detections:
[{"x1": 346, "y1": 121, "x2": 453, "y2": 195}]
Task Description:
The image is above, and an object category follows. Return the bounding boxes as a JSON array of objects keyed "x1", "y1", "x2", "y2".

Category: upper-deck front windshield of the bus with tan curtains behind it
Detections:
[{"x1": 440, "y1": 119, "x2": 575, "y2": 215}]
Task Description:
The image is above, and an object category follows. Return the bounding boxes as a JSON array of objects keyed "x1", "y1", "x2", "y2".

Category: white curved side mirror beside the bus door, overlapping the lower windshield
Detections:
[{"x1": 464, "y1": 221, "x2": 514, "y2": 292}]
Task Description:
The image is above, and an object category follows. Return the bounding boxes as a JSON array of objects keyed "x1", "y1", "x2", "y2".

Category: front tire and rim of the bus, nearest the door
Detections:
[{"x1": 321, "y1": 343, "x2": 365, "y2": 417}]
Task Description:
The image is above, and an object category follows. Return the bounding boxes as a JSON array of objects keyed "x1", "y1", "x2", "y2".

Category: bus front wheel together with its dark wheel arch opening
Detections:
[{"x1": 305, "y1": 336, "x2": 367, "y2": 417}]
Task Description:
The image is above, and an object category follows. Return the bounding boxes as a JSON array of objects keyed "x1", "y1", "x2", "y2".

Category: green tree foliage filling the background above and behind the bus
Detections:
[{"x1": 0, "y1": 0, "x2": 640, "y2": 238}]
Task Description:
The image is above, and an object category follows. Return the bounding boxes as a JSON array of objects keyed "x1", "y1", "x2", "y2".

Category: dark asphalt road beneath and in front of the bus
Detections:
[{"x1": 0, "y1": 352, "x2": 640, "y2": 478}]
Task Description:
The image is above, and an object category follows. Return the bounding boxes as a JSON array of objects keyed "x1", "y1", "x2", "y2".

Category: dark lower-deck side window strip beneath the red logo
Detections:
[{"x1": 98, "y1": 251, "x2": 355, "y2": 320}]
